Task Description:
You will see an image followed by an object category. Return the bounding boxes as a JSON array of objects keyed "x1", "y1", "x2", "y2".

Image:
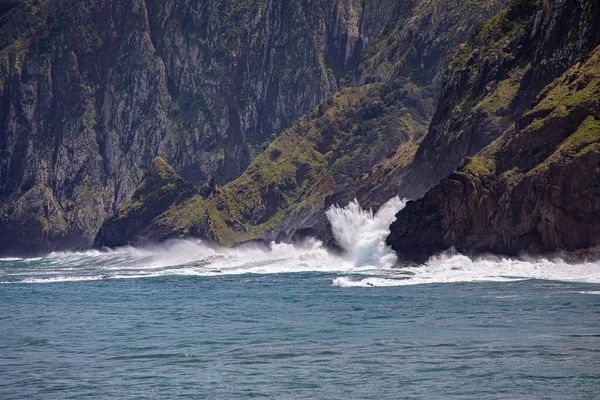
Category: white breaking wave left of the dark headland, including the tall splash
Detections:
[{"x1": 0, "y1": 198, "x2": 405, "y2": 283}]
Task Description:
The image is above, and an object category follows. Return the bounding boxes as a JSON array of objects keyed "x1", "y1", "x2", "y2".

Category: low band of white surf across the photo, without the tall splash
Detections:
[{"x1": 0, "y1": 244, "x2": 600, "y2": 287}]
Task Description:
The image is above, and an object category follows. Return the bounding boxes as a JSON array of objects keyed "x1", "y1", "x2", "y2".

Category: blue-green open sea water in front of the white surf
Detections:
[{"x1": 0, "y1": 252, "x2": 600, "y2": 399}]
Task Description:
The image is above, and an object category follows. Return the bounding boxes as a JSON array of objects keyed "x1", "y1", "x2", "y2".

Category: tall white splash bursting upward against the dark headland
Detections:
[{"x1": 326, "y1": 197, "x2": 406, "y2": 268}]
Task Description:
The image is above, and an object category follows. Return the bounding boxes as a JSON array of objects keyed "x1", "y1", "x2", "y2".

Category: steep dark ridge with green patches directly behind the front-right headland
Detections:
[{"x1": 405, "y1": 0, "x2": 600, "y2": 193}]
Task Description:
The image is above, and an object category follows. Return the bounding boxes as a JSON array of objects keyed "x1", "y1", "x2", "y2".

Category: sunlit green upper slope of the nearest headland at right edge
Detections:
[{"x1": 463, "y1": 7, "x2": 600, "y2": 183}]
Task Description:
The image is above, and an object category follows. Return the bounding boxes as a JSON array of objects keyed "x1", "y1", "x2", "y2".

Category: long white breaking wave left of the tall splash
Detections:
[{"x1": 0, "y1": 240, "x2": 352, "y2": 283}]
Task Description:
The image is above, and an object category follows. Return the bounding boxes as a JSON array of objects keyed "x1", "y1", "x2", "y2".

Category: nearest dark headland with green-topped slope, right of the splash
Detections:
[{"x1": 388, "y1": 42, "x2": 600, "y2": 261}]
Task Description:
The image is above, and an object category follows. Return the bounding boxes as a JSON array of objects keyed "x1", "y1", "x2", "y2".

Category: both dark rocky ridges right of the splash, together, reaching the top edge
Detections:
[{"x1": 388, "y1": 0, "x2": 600, "y2": 261}]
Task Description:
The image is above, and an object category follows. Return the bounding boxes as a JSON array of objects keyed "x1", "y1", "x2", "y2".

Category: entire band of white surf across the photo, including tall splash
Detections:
[{"x1": 0, "y1": 197, "x2": 600, "y2": 287}]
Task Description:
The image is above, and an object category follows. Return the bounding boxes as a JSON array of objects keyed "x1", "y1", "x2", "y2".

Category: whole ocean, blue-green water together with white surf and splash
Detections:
[{"x1": 0, "y1": 199, "x2": 600, "y2": 399}]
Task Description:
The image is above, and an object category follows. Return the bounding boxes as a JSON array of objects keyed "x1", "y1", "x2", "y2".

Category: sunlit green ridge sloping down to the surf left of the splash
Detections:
[{"x1": 103, "y1": 84, "x2": 426, "y2": 245}]
